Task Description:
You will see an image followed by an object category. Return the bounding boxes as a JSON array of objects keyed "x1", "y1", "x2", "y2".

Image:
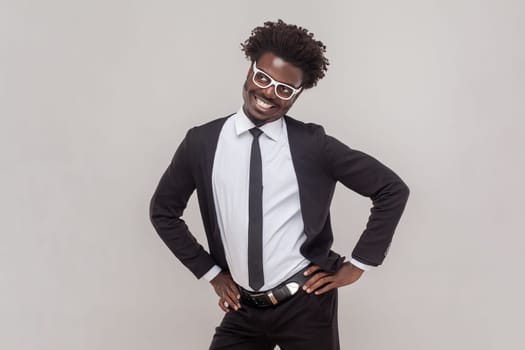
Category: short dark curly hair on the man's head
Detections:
[{"x1": 241, "y1": 20, "x2": 329, "y2": 89}]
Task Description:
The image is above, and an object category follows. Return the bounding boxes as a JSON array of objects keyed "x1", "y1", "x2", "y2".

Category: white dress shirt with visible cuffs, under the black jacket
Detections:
[{"x1": 204, "y1": 108, "x2": 370, "y2": 290}]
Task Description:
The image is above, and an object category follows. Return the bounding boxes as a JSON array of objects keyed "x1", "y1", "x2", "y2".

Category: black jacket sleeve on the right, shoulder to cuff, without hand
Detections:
[{"x1": 323, "y1": 135, "x2": 409, "y2": 266}]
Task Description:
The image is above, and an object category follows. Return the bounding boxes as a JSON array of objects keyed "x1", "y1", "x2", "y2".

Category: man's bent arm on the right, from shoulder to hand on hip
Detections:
[{"x1": 303, "y1": 133, "x2": 409, "y2": 294}]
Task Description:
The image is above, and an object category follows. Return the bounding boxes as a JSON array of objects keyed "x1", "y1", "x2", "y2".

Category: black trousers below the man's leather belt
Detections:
[{"x1": 210, "y1": 289, "x2": 339, "y2": 350}]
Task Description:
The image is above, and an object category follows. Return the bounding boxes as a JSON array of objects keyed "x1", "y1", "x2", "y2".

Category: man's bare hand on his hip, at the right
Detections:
[{"x1": 303, "y1": 261, "x2": 364, "y2": 295}]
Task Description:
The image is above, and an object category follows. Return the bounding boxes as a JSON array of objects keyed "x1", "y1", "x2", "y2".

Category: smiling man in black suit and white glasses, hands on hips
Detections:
[{"x1": 150, "y1": 20, "x2": 409, "y2": 350}]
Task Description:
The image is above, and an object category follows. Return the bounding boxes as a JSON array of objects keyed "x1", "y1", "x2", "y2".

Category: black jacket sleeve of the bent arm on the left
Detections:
[{"x1": 150, "y1": 130, "x2": 215, "y2": 278}]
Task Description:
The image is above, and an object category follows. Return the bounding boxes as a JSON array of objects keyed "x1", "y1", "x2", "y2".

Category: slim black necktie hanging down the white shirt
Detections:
[{"x1": 248, "y1": 128, "x2": 264, "y2": 291}]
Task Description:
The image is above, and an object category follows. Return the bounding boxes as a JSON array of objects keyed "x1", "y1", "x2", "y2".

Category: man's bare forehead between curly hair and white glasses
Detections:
[{"x1": 257, "y1": 52, "x2": 303, "y2": 87}]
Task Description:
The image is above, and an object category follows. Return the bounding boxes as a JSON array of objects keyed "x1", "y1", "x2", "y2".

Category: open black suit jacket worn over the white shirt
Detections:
[{"x1": 150, "y1": 116, "x2": 409, "y2": 278}]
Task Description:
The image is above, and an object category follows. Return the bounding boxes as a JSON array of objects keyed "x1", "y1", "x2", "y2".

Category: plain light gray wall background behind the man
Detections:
[{"x1": 0, "y1": 0, "x2": 525, "y2": 350}]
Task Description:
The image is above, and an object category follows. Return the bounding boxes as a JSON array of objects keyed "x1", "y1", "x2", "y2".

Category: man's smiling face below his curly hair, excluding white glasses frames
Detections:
[{"x1": 242, "y1": 52, "x2": 303, "y2": 125}]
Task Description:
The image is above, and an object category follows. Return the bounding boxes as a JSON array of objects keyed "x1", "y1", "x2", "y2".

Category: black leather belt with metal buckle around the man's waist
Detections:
[{"x1": 239, "y1": 267, "x2": 310, "y2": 307}]
